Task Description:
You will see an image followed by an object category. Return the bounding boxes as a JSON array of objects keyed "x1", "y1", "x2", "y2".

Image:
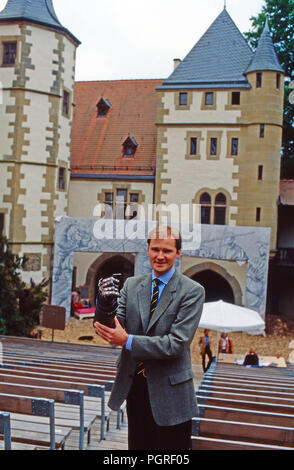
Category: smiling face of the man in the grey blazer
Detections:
[{"x1": 147, "y1": 238, "x2": 181, "y2": 277}]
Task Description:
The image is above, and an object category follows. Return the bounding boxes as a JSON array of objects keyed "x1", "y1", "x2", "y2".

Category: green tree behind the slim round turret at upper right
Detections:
[{"x1": 245, "y1": 0, "x2": 294, "y2": 178}]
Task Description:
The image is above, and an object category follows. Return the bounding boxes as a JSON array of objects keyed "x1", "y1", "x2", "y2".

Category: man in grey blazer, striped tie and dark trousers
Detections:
[{"x1": 94, "y1": 227, "x2": 204, "y2": 450}]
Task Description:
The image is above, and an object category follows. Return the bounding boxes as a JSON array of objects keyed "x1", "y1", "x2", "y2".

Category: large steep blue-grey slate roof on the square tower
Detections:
[{"x1": 158, "y1": 8, "x2": 253, "y2": 89}]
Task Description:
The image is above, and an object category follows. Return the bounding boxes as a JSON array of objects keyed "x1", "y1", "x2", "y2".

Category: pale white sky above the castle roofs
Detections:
[{"x1": 0, "y1": 0, "x2": 264, "y2": 81}]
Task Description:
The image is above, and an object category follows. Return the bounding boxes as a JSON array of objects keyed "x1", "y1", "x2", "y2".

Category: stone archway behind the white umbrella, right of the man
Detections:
[{"x1": 184, "y1": 262, "x2": 243, "y2": 305}]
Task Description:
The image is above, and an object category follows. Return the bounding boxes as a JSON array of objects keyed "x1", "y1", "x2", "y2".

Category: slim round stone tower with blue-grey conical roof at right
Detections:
[{"x1": 236, "y1": 22, "x2": 284, "y2": 250}]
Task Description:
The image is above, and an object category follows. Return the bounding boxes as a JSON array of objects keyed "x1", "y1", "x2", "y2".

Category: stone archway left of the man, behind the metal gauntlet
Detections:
[{"x1": 86, "y1": 253, "x2": 135, "y2": 305}]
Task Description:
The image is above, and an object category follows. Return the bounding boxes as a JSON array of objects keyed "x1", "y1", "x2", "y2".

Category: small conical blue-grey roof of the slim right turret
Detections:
[{"x1": 246, "y1": 20, "x2": 285, "y2": 73}]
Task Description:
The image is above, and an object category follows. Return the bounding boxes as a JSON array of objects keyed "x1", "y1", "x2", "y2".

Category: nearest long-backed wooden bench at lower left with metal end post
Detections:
[{"x1": 0, "y1": 383, "x2": 85, "y2": 450}]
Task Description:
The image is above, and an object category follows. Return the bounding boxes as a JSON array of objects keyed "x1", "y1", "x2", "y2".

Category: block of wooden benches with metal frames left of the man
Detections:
[{"x1": 0, "y1": 336, "x2": 123, "y2": 450}]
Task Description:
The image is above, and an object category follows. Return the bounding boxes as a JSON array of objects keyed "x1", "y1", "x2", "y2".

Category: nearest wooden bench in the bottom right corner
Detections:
[{"x1": 191, "y1": 436, "x2": 293, "y2": 451}]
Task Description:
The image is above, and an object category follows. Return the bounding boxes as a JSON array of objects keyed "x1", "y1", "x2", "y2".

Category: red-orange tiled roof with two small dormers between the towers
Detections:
[{"x1": 71, "y1": 80, "x2": 162, "y2": 175}]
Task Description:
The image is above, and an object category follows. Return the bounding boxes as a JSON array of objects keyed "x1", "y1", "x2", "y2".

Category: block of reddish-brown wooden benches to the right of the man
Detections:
[{"x1": 192, "y1": 362, "x2": 294, "y2": 450}]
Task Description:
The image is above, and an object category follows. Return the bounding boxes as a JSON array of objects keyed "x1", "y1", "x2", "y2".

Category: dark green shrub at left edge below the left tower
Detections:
[{"x1": 0, "y1": 236, "x2": 48, "y2": 336}]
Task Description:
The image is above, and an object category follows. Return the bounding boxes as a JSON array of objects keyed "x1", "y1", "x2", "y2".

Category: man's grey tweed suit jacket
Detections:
[{"x1": 108, "y1": 271, "x2": 204, "y2": 426}]
